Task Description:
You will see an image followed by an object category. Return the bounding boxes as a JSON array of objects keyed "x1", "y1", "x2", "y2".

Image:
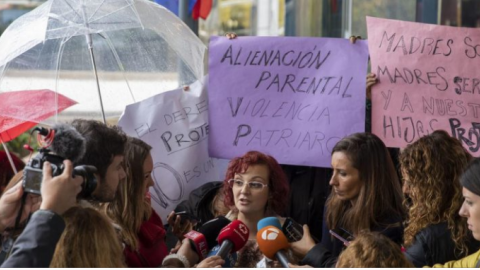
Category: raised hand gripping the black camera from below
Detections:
[{"x1": 40, "y1": 160, "x2": 83, "y2": 215}]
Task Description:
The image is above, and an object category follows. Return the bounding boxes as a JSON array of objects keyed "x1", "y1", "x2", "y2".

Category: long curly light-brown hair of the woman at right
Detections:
[{"x1": 400, "y1": 130, "x2": 472, "y2": 256}]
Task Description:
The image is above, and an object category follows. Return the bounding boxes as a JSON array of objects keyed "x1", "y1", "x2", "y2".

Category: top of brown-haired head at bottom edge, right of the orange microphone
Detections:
[{"x1": 336, "y1": 232, "x2": 413, "y2": 268}]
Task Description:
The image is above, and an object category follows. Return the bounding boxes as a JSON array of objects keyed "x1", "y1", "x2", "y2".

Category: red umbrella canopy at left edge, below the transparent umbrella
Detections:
[{"x1": 0, "y1": 89, "x2": 76, "y2": 143}]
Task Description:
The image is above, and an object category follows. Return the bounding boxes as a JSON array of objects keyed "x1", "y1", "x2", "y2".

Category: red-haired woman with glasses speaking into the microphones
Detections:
[{"x1": 224, "y1": 151, "x2": 289, "y2": 267}]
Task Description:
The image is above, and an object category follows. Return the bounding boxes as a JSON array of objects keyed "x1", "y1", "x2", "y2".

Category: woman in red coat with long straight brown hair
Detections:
[{"x1": 104, "y1": 137, "x2": 168, "y2": 267}]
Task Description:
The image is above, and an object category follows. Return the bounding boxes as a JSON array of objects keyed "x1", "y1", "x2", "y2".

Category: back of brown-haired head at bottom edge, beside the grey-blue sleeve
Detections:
[{"x1": 50, "y1": 207, "x2": 125, "y2": 268}]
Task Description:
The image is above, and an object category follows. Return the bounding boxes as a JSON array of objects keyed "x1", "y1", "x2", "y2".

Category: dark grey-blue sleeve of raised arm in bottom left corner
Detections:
[{"x1": 2, "y1": 210, "x2": 65, "y2": 268}]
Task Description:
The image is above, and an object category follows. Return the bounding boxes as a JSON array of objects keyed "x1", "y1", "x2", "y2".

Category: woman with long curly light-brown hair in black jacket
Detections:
[{"x1": 400, "y1": 130, "x2": 478, "y2": 267}]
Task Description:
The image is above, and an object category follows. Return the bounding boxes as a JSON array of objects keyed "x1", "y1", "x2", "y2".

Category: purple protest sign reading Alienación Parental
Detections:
[{"x1": 208, "y1": 37, "x2": 368, "y2": 167}]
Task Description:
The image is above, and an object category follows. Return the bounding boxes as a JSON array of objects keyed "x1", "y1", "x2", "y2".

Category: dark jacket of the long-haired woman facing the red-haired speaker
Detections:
[{"x1": 300, "y1": 213, "x2": 404, "y2": 268}]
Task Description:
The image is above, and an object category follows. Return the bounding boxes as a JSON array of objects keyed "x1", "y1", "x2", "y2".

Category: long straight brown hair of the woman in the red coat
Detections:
[{"x1": 106, "y1": 137, "x2": 152, "y2": 250}]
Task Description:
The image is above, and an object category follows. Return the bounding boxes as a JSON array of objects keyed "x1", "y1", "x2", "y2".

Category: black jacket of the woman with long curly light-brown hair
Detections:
[{"x1": 405, "y1": 222, "x2": 480, "y2": 267}]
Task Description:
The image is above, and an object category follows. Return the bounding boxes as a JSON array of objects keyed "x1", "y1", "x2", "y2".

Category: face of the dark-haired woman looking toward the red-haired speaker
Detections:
[{"x1": 329, "y1": 152, "x2": 362, "y2": 201}]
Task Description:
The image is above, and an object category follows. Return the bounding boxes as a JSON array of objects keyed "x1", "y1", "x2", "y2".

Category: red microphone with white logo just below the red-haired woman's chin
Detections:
[{"x1": 216, "y1": 219, "x2": 249, "y2": 259}]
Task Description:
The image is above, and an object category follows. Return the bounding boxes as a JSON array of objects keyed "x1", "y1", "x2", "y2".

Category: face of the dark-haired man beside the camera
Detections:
[{"x1": 93, "y1": 155, "x2": 127, "y2": 202}]
